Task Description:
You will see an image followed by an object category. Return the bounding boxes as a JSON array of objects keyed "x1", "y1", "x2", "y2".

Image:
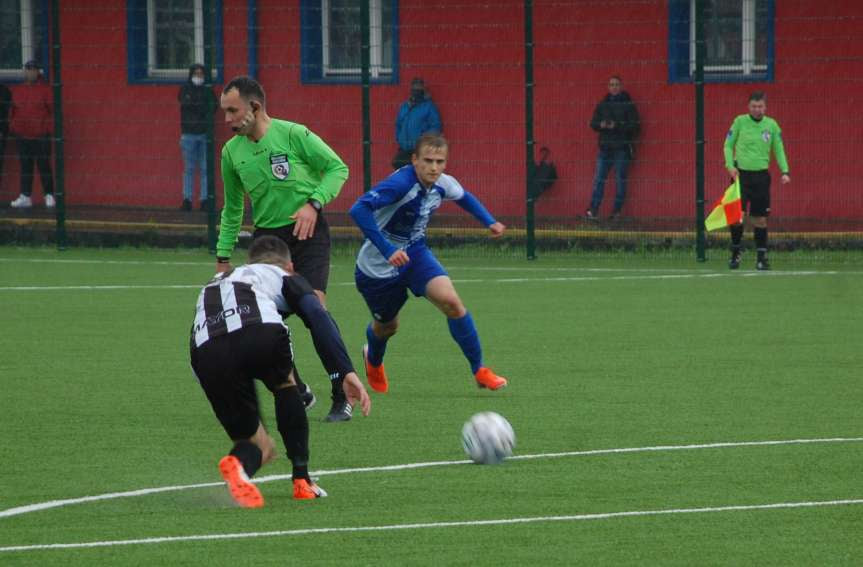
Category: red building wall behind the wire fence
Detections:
[{"x1": 0, "y1": 0, "x2": 863, "y2": 226}]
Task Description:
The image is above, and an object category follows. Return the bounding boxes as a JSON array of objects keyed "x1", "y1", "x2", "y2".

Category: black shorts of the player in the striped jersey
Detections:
[{"x1": 191, "y1": 323, "x2": 294, "y2": 439}]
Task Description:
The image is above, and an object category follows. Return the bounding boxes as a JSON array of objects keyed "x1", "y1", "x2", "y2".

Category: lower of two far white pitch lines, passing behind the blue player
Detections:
[{"x1": 0, "y1": 271, "x2": 863, "y2": 291}]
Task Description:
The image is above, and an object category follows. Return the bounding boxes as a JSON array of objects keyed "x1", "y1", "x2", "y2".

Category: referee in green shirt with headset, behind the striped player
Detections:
[{"x1": 216, "y1": 76, "x2": 353, "y2": 421}]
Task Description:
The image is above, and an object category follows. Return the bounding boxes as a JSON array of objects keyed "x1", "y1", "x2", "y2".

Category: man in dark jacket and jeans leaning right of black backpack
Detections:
[{"x1": 585, "y1": 75, "x2": 641, "y2": 219}]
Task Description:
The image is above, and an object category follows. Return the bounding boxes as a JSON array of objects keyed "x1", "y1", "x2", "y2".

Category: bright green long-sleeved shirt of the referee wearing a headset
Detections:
[{"x1": 216, "y1": 122, "x2": 348, "y2": 258}]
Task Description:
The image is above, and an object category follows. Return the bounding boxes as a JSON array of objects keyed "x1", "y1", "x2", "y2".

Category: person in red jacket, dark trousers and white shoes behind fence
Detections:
[{"x1": 9, "y1": 60, "x2": 55, "y2": 209}]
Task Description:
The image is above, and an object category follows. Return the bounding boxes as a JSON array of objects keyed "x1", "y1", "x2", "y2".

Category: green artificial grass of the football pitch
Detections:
[{"x1": 0, "y1": 247, "x2": 863, "y2": 566}]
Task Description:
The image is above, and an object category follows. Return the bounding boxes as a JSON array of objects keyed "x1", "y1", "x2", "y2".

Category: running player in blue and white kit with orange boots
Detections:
[{"x1": 350, "y1": 134, "x2": 506, "y2": 392}]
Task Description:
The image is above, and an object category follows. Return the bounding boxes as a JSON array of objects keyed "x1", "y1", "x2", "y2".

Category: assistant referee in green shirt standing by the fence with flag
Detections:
[{"x1": 724, "y1": 91, "x2": 791, "y2": 270}]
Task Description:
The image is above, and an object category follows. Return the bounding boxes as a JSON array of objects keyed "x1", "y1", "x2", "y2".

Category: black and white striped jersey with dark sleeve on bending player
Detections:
[{"x1": 191, "y1": 264, "x2": 354, "y2": 379}]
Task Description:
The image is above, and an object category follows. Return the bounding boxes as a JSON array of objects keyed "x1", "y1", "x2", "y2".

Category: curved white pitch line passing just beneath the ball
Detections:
[{"x1": 0, "y1": 437, "x2": 863, "y2": 518}]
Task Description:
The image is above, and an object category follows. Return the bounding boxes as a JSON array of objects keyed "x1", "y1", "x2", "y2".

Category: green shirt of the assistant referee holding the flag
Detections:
[{"x1": 724, "y1": 114, "x2": 788, "y2": 173}]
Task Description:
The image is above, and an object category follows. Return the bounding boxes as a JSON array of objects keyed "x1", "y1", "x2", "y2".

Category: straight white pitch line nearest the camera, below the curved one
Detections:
[{"x1": 0, "y1": 499, "x2": 863, "y2": 552}]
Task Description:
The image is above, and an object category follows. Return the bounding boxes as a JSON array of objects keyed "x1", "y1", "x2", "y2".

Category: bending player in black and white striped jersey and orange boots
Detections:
[{"x1": 190, "y1": 236, "x2": 371, "y2": 507}]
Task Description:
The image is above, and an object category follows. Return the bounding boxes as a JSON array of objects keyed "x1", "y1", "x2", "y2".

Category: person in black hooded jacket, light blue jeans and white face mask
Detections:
[{"x1": 177, "y1": 63, "x2": 216, "y2": 211}]
